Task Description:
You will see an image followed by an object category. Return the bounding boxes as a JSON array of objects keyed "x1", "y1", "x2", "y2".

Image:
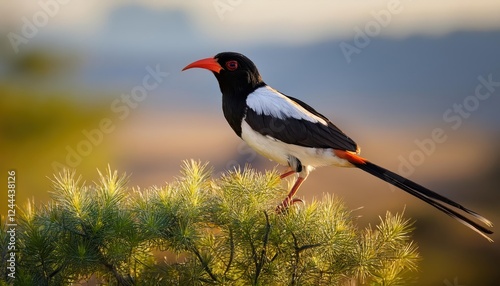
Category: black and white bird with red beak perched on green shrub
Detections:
[{"x1": 182, "y1": 52, "x2": 493, "y2": 242}]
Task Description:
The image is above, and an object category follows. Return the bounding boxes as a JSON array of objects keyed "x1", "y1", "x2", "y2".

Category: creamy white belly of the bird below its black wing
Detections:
[{"x1": 241, "y1": 120, "x2": 352, "y2": 167}]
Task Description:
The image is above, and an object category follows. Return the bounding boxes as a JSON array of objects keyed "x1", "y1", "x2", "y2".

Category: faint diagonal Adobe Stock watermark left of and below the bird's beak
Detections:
[{"x1": 52, "y1": 64, "x2": 169, "y2": 173}]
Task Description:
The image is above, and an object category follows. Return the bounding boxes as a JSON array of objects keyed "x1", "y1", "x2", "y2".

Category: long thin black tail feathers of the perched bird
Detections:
[{"x1": 353, "y1": 161, "x2": 493, "y2": 242}]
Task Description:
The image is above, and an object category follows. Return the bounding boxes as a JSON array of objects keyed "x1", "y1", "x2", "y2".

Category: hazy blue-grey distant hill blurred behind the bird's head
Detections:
[{"x1": 71, "y1": 5, "x2": 500, "y2": 130}]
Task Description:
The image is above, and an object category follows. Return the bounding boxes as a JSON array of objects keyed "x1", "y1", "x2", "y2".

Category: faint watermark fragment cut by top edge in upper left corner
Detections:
[{"x1": 7, "y1": 0, "x2": 71, "y2": 54}]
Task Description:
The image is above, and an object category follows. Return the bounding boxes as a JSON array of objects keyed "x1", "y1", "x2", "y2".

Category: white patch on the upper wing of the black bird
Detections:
[{"x1": 247, "y1": 85, "x2": 328, "y2": 125}]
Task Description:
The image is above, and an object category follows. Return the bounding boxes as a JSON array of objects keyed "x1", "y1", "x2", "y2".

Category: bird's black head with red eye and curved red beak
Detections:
[{"x1": 183, "y1": 52, "x2": 264, "y2": 96}]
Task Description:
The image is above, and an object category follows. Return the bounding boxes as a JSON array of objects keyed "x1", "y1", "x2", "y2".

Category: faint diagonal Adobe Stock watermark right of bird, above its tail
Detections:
[{"x1": 398, "y1": 74, "x2": 500, "y2": 184}]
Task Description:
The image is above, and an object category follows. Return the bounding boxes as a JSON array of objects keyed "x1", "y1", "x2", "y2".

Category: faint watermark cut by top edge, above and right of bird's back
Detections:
[{"x1": 339, "y1": 0, "x2": 404, "y2": 64}]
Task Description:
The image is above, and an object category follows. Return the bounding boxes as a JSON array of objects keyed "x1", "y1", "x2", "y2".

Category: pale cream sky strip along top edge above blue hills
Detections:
[{"x1": 1, "y1": 0, "x2": 500, "y2": 45}]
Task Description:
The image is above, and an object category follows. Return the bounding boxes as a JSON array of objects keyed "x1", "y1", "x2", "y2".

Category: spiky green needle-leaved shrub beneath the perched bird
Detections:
[{"x1": 0, "y1": 161, "x2": 418, "y2": 285}]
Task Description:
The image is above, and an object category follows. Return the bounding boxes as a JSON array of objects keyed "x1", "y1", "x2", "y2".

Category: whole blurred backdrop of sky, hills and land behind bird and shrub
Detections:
[{"x1": 0, "y1": 0, "x2": 500, "y2": 285}]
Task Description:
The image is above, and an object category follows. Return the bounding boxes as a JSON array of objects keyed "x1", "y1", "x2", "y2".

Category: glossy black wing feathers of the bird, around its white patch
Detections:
[{"x1": 244, "y1": 94, "x2": 357, "y2": 152}]
